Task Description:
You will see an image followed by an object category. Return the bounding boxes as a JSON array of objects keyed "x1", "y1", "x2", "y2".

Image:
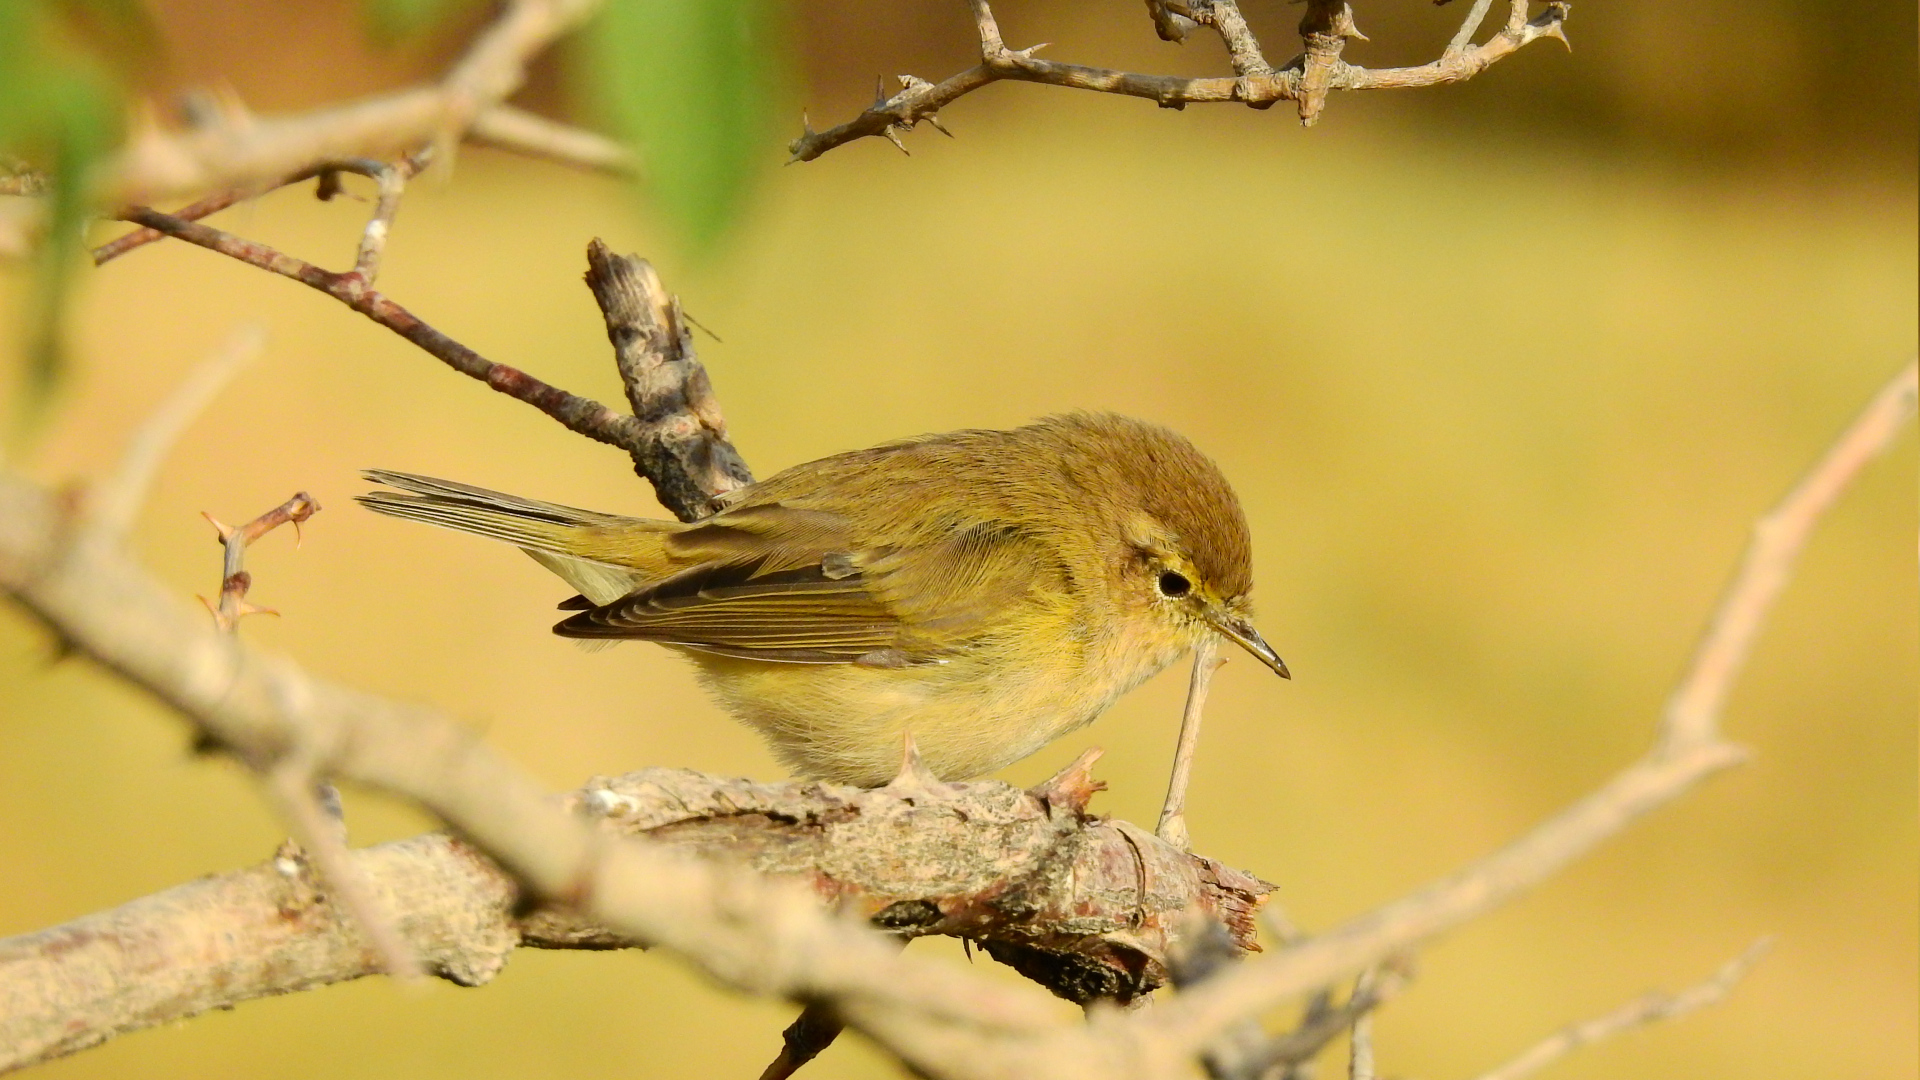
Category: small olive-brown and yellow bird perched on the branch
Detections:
[{"x1": 359, "y1": 413, "x2": 1290, "y2": 786}]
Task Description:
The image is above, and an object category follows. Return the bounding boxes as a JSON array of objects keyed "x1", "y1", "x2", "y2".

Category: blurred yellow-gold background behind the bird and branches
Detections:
[{"x1": 0, "y1": 0, "x2": 1920, "y2": 1080}]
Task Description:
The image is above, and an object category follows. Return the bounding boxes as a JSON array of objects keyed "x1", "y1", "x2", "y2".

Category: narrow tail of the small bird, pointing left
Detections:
[{"x1": 357, "y1": 469, "x2": 680, "y2": 603}]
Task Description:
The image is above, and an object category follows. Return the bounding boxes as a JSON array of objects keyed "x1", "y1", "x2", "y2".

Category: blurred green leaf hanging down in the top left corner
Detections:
[{"x1": 0, "y1": 0, "x2": 123, "y2": 427}]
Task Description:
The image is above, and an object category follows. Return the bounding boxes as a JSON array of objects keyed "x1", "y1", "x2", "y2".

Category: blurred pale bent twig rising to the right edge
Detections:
[{"x1": 1140, "y1": 365, "x2": 1916, "y2": 1053}]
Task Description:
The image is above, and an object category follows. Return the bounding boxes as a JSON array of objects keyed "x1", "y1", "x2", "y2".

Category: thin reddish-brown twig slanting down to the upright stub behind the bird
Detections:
[{"x1": 123, "y1": 208, "x2": 649, "y2": 454}]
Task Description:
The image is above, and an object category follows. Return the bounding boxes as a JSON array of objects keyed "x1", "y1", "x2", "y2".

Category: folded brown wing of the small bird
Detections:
[{"x1": 555, "y1": 503, "x2": 1050, "y2": 667}]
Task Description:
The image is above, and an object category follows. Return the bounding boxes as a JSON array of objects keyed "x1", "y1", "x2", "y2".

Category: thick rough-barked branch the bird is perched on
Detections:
[{"x1": 0, "y1": 757, "x2": 1269, "y2": 1072}]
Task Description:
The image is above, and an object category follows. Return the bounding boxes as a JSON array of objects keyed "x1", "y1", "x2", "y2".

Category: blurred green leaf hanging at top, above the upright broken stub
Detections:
[{"x1": 580, "y1": 0, "x2": 785, "y2": 250}]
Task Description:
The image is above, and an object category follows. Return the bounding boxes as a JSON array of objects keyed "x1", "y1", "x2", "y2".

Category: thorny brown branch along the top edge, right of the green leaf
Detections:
[{"x1": 787, "y1": 0, "x2": 1571, "y2": 161}]
